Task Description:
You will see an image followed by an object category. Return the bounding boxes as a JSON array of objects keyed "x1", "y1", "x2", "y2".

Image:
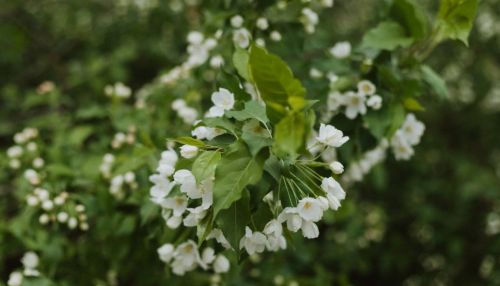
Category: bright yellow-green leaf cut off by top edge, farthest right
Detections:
[{"x1": 437, "y1": 0, "x2": 479, "y2": 46}]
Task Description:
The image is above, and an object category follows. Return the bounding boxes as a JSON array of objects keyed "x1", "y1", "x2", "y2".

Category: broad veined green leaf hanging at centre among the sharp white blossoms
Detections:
[{"x1": 213, "y1": 141, "x2": 264, "y2": 218}]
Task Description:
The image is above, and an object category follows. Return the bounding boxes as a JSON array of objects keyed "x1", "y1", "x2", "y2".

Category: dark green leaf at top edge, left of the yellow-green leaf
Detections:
[{"x1": 390, "y1": 0, "x2": 429, "y2": 40}]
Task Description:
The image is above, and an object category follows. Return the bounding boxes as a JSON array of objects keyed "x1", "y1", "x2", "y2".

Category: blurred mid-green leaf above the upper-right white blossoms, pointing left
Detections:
[{"x1": 361, "y1": 21, "x2": 413, "y2": 51}]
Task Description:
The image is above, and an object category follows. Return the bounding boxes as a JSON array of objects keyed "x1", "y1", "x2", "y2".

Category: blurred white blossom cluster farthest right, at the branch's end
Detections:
[{"x1": 390, "y1": 113, "x2": 425, "y2": 160}]
